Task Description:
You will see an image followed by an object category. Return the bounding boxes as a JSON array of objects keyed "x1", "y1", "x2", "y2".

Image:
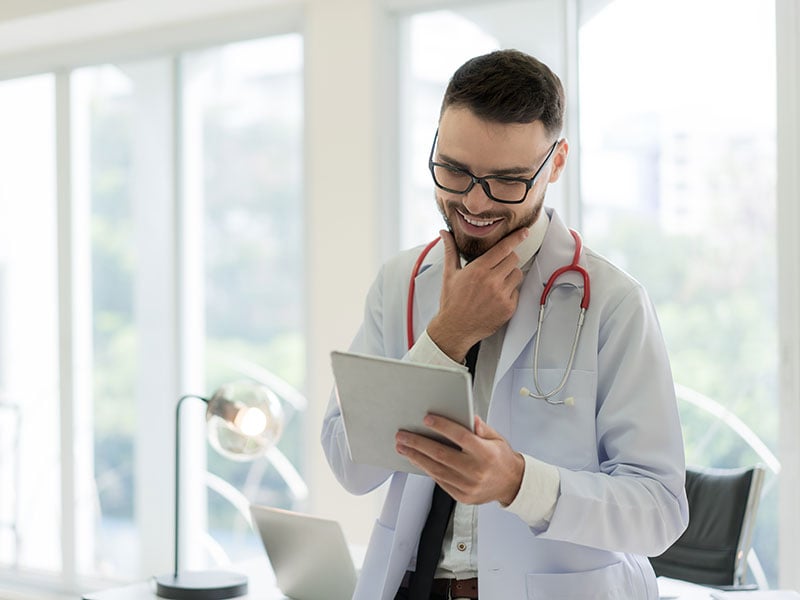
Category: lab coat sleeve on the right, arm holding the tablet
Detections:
[{"x1": 534, "y1": 285, "x2": 688, "y2": 556}]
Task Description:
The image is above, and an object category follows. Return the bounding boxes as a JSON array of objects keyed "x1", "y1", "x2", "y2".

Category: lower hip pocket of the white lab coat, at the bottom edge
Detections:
[{"x1": 527, "y1": 562, "x2": 634, "y2": 600}]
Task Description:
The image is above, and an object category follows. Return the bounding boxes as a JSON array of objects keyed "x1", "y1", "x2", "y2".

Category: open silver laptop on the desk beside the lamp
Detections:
[{"x1": 250, "y1": 504, "x2": 357, "y2": 600}]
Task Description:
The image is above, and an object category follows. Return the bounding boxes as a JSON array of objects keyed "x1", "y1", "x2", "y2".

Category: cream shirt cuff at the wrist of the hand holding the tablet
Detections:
[{"x1": 505, "y1": 454, "x2": 561, "y2": 527}]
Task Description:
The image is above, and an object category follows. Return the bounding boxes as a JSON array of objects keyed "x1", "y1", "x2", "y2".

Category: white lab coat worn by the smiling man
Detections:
[{"x1": 322, "y1": 209, "x2": 688, "y2": 600}]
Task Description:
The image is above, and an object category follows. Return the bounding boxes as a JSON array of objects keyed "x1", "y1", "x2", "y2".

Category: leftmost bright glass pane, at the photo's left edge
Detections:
[{"x1": 0, "y1": 75, "x2": 61, "y2": 571}]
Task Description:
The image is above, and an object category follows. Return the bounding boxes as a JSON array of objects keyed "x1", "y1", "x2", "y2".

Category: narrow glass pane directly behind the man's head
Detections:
[{"x1": 398, "y1": 0, "x2": 564, "y2": 248}]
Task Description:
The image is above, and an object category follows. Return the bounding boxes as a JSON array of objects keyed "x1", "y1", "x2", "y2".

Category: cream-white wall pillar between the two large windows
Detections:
[{"x1": 305, "y1": 0, "x2": 388, "y2": 544}]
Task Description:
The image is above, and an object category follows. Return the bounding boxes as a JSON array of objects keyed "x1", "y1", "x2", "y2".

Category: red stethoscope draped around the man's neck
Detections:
[{"x1": 406, "y1": 229, "x2": 591, "y2": 406}]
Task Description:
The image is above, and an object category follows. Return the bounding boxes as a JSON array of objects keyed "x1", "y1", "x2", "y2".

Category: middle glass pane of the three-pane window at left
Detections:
[{"x1": 71, "y1": 60, "x2": 177, "y2": 579}]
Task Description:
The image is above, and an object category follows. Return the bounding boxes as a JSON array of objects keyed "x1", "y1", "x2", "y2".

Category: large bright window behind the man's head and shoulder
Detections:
[{"x1": 397, "y1": 0, "x2": 780, "y2": 585}]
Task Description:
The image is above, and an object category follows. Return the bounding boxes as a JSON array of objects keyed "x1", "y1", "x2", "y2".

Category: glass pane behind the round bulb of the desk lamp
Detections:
[{"x1": 182, "y1": 34, "x2": 305, "y2": 560}]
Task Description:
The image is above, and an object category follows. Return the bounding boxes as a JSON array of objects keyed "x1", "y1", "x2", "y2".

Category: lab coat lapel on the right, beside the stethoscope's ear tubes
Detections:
[{"x1": 494, "y1": 209, "x2": 586, "y2": 386}]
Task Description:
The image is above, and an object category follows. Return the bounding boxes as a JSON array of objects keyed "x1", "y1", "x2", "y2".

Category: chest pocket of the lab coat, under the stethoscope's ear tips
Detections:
[{"x1": 510, "y1": 368, "x2": 599, "y2": 470}]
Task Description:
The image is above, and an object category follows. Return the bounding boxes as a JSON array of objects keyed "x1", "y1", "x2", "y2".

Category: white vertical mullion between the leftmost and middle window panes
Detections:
[{"x1": 55, "y1": 63, "x2": 96, "y2": 589}]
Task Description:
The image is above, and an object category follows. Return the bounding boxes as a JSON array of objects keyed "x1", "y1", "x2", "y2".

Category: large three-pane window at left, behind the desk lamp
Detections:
[{"x1": 0, "y1": 34, "x2": 307, "y2": 581}]
